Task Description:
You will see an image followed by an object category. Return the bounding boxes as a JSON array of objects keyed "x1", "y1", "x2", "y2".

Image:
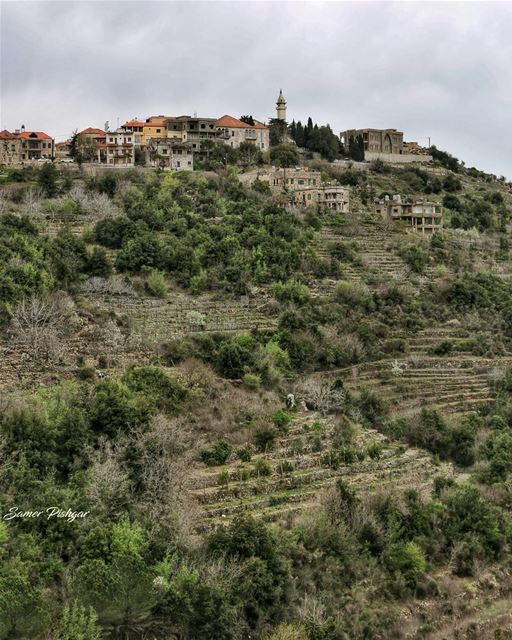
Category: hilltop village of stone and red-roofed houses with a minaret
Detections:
[{"x1": 0, "y1": 90, "x2": 443, "y2": 234}]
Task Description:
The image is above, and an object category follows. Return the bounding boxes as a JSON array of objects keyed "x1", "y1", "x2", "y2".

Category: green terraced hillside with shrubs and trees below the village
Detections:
[{"x1": 0, "y1": 155, "x2": 512, "y2": 640}]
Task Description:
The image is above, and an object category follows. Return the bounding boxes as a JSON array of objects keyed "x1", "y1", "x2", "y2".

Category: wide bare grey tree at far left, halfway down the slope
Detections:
[{"x1": 11, "y1": 291, "x2": 76, "y2": 361}]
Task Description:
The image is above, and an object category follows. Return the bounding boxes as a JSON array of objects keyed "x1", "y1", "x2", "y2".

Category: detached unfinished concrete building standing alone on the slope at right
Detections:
[{"x1": 375, "y1": 195, "x2": 443, "y2": 235}]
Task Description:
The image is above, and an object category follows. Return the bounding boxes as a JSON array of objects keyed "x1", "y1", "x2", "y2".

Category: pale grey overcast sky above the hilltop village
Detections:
[{"x1": 0, "y1": 0, "x2": 512, "y2": 179}]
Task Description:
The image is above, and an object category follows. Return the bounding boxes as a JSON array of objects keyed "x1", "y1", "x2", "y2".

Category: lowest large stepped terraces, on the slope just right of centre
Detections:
[{"x1": 186, "y1": 413, "x2": 453, "y2": 528}]
